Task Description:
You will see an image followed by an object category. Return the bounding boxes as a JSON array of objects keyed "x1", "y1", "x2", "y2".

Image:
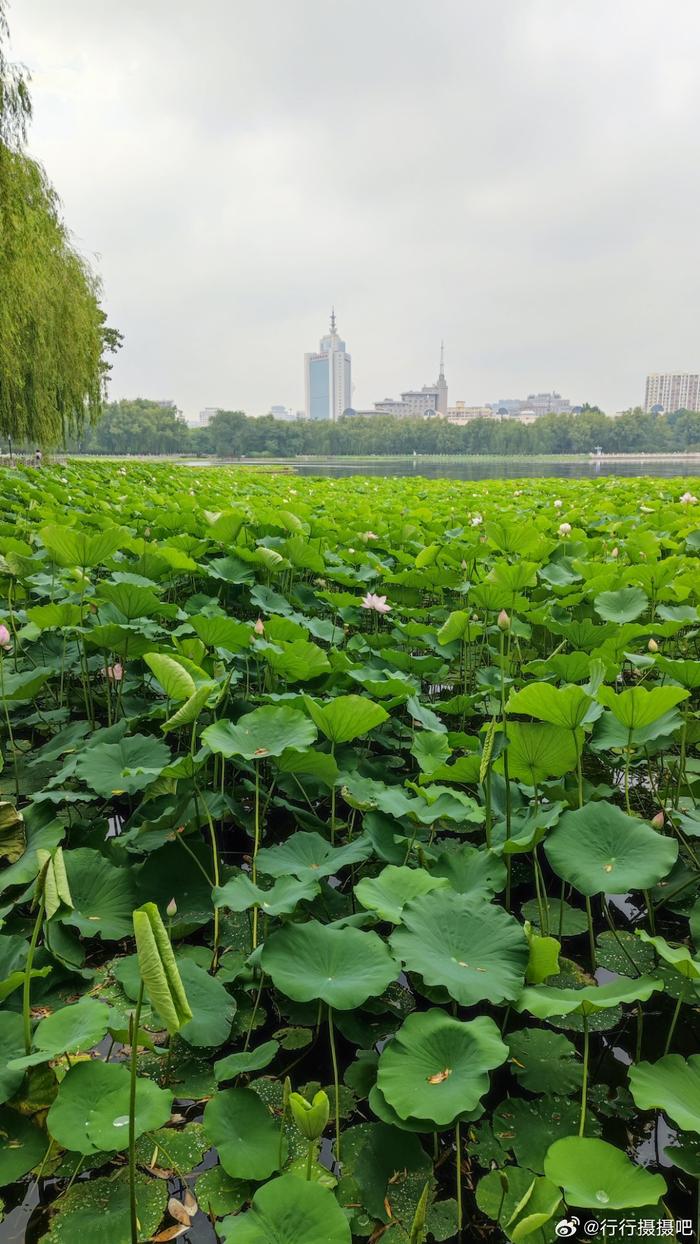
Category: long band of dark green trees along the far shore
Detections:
[{"x1": 56, "y1": 398, "x2": 700, "y2": 458}]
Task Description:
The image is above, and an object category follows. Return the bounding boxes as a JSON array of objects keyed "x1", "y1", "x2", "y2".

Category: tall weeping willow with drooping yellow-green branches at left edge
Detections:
[{"x1": 0, "y1": 0, "x2": 121, "y2": 444}]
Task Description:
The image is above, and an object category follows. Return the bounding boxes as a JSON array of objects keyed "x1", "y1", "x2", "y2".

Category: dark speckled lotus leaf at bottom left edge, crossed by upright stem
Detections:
[{"x1": 42, "y1": 1171, "x2": 168, "y2": 1244}]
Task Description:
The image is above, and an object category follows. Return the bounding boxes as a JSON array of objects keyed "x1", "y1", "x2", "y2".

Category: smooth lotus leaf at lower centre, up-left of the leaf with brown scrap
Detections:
[{"x1": 262, "y1": 921, "x2": 399, "y2": 1010}]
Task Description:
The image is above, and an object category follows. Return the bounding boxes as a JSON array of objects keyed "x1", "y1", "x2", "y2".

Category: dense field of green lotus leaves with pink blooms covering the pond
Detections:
[{"x1": 0, "y1": 464, "x2": 700, "y2": 1244}]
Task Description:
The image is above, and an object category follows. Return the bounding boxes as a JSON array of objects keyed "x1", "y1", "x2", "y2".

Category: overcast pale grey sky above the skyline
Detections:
[{"x1": 10, "y1": 0, "x2": 700, "y2": 415}]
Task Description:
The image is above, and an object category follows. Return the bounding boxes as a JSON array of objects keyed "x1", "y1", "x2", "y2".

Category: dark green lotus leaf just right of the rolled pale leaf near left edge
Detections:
[{"x1": 61, "y1": 847, "x2": 136, "y2": 940}]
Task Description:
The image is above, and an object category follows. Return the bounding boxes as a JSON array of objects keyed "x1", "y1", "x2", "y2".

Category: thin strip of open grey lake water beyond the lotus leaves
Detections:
[{"x1": 188, "y1": 455, "x2": 700, "y2": 480}]
